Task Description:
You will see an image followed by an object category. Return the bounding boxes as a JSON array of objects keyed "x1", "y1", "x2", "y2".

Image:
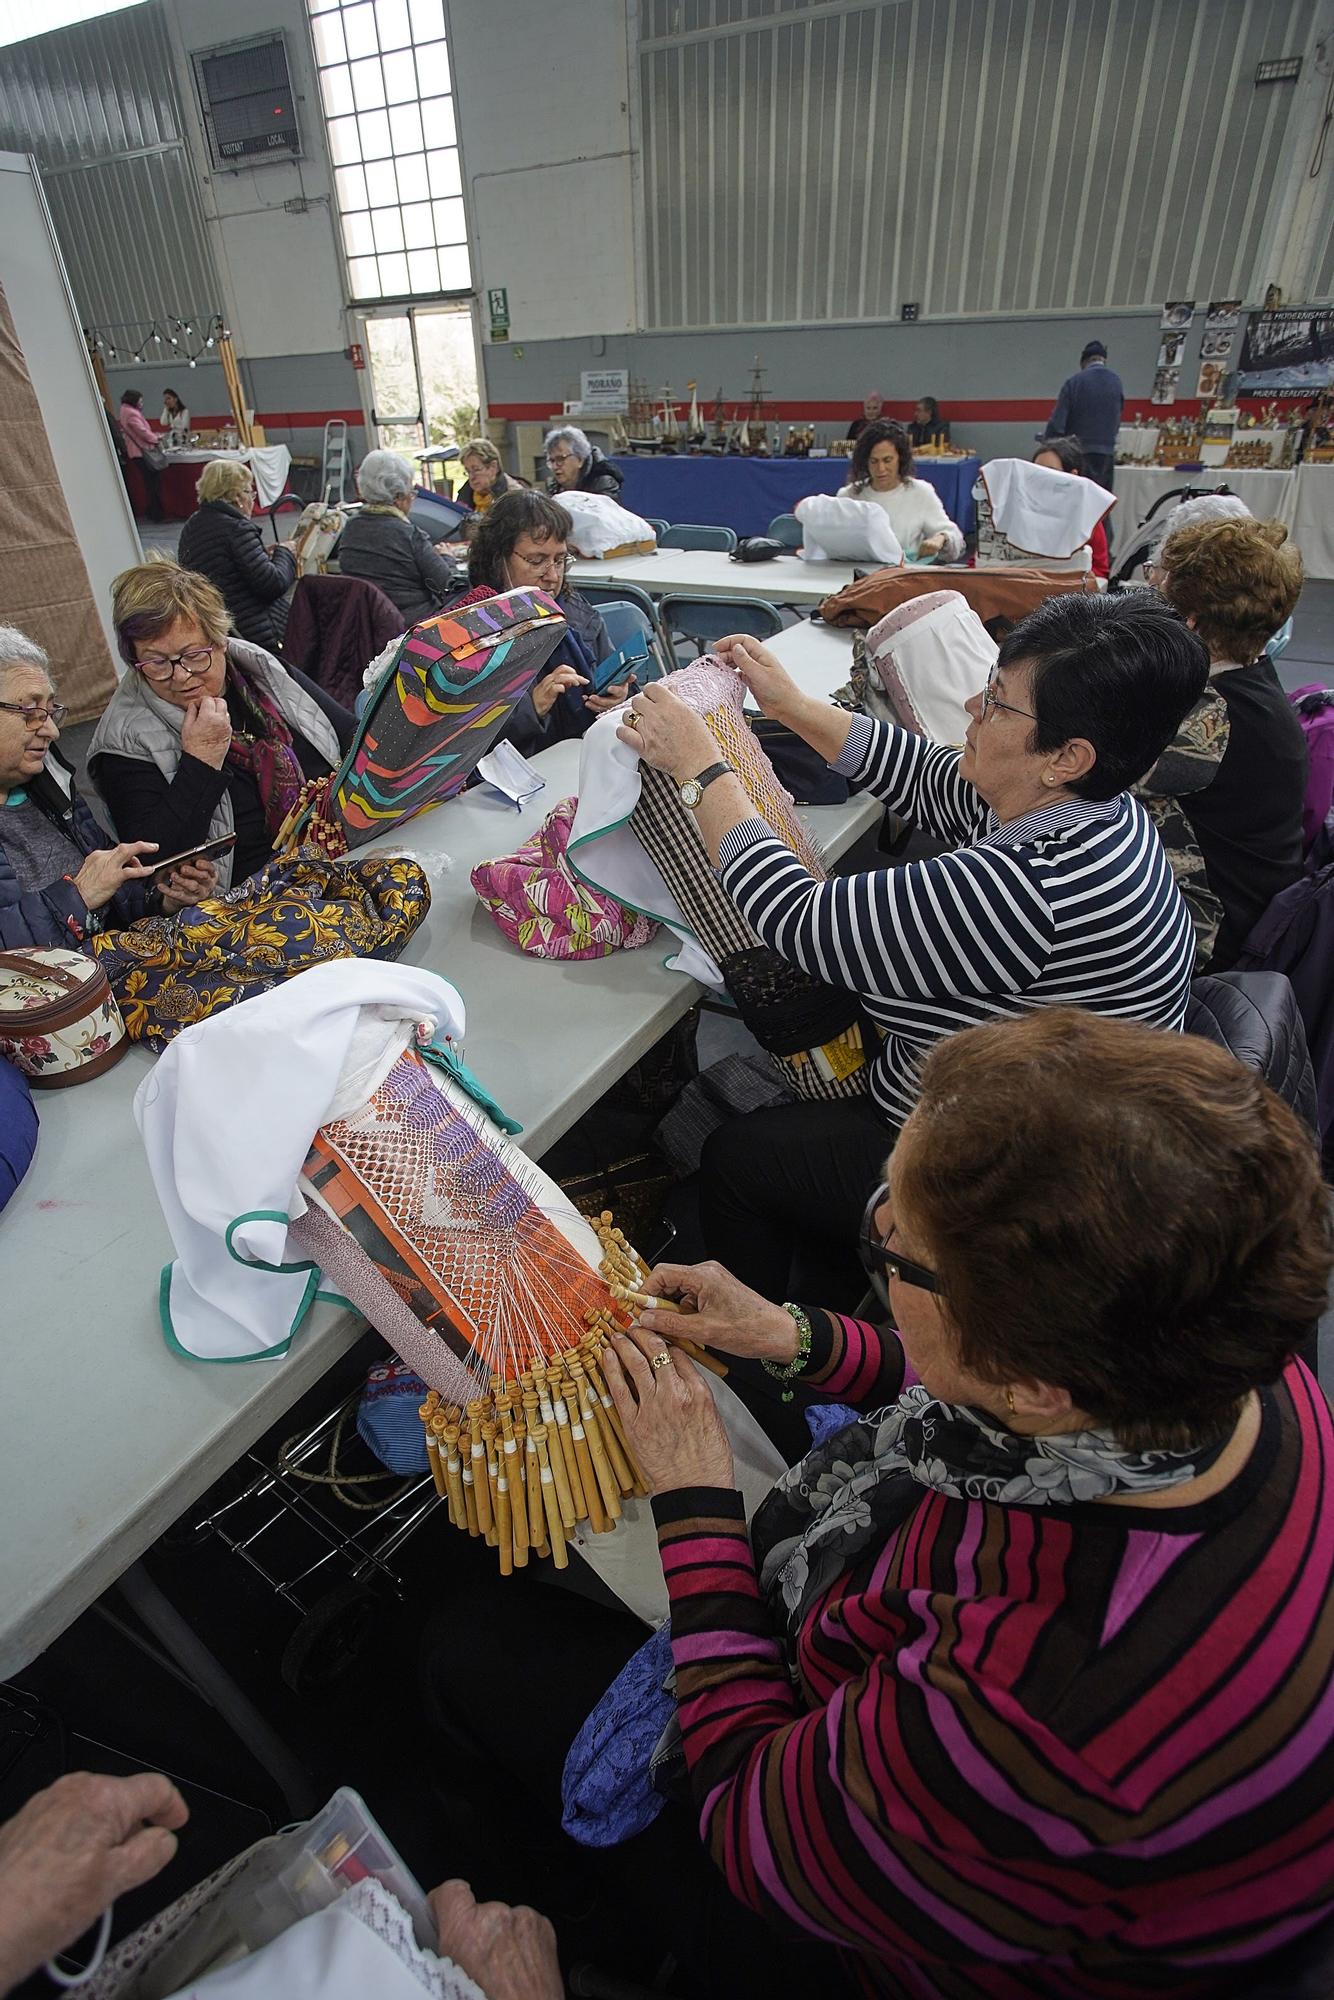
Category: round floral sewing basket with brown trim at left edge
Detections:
[{"x1": 0, "y1": 944, "x2": 130, "y2": 1090}]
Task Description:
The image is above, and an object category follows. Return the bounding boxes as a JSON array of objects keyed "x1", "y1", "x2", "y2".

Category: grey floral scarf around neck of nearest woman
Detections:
[{"x1": 750, "y1": 1384, "x2": 1228, "y2": 1648}]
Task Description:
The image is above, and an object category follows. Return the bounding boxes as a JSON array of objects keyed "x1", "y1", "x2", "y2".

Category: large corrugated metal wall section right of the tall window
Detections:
[{"x1": 638, "y1": 0, "x2": 1316, "y2": 328}]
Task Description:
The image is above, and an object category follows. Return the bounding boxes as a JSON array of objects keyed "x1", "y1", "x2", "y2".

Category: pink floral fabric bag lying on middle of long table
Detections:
[{"x1": 472, "y1": 798, "x2": 658, "y2": 958}]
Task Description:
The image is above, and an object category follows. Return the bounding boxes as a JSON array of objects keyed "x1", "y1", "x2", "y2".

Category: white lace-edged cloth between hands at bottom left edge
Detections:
[{"x1": 172, "y1": 1876, "x2": 486, "y2": 2000}]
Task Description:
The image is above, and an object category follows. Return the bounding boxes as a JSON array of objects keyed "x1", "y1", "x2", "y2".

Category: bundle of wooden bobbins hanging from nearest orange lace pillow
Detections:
[{"x1": 418, "y1": 1210, "x2": 726, "y2": 1576}]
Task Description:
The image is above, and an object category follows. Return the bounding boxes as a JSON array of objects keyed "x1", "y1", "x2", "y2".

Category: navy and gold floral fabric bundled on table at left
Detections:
[{"x1": 88, "y1": 848, "x2": 430, "y2": 1048}]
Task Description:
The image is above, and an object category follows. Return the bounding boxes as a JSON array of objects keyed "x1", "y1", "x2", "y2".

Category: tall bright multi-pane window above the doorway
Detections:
[{"x1": 308, "y1": 0, "x2": 472, "y2": 304}]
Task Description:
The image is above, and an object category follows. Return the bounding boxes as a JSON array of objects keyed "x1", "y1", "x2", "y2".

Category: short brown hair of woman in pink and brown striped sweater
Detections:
[{"x1": 892, "y1": 1008, "x2": 1334, "y2": 1450}]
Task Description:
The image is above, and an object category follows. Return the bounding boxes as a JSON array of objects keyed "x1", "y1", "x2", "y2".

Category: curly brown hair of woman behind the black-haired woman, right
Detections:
[{"x1": 1158, "y1": 520, "x2": 1304, "y2": 666}]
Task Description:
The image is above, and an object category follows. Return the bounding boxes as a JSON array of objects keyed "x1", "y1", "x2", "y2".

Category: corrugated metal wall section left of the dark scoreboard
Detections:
[{"x1": 0, "y1": 0, "x2": 222, "y2": 346}]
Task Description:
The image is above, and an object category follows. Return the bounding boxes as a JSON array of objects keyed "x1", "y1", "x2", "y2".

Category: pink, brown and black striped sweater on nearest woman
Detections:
[{"x1": 654, "y1": 1316, "x2": 1334, "y2": 2000}]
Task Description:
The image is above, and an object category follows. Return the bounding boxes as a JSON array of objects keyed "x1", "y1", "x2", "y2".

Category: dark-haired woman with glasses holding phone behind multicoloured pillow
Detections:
[{"x1": 450, "y1": 490, "x2": 630, "y2": 756}]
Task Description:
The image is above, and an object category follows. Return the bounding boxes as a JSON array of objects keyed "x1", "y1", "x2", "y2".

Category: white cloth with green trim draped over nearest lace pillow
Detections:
[{"x1": 134, "y1": 958, "x2": 464, "y2": 1362}]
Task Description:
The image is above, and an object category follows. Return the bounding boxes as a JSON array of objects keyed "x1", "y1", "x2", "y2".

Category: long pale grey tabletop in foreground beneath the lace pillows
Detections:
[{"x1": 0, "y1": 728, "x2": 880, "y2": 1678}]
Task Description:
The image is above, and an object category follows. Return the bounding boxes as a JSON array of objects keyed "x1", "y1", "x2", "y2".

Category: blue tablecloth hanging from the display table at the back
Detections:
[{"x1": 614, "y1": 454, "x2": 982, "y2": 534}]
